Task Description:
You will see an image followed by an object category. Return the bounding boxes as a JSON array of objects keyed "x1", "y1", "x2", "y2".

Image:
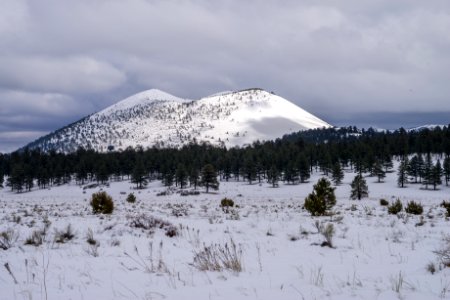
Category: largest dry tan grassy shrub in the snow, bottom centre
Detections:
[{"x1": 193, "y1": 239, "x2": 242, "y2": 272}]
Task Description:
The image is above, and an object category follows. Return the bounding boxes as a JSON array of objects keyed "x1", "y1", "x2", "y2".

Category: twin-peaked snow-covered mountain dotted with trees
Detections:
[{"x1": 27, "y1": 89, "x2": 330, "y2": 152}]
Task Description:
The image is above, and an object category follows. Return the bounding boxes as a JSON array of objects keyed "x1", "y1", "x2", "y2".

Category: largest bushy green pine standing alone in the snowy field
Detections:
[{"x1": 304, "y1": 178, "x2": 336, "y2": 216}]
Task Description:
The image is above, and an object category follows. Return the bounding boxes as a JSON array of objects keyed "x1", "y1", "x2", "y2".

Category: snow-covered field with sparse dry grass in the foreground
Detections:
[{"x1": 0, "y1": 173, "x2": 450, "y2": 300}]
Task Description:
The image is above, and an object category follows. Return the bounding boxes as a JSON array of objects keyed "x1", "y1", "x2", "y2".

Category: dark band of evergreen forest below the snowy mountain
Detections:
[{"x1": 0, "y1": 126, "x2": 450, "y2": 192}]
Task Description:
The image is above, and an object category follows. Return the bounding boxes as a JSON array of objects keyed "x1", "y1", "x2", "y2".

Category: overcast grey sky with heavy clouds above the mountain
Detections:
[{"x1": 0, "y1": 0, "x2": 450, "y2": 152}]
